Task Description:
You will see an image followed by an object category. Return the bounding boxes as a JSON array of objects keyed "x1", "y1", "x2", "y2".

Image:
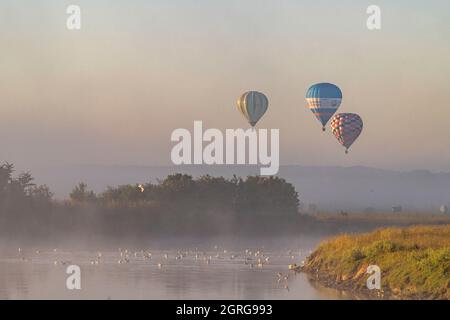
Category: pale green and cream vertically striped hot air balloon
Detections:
[{"x1": 237, "y1": 91, "x2": 269, "y2": 127}]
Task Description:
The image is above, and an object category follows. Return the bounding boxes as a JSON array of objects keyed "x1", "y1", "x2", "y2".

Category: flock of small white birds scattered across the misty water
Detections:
[{"x1": 14, "y1": 246, "x2": 312, "y2": 291}]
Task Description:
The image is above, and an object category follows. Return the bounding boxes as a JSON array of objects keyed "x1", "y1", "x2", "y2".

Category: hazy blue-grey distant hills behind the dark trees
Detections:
[{"x1": 32, "y1": 165, "x2": 450, "y2": 213}]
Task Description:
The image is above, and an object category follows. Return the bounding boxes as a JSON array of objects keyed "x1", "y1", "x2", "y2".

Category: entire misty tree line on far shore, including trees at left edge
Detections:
[{"x1": 0, "y1": 163, "x2": 299, "y2": 237}]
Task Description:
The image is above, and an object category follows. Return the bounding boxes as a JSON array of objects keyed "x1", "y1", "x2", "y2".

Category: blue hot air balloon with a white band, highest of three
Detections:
[{"x1": 306, "y1": 83, "x2": 342, "y2": 131}]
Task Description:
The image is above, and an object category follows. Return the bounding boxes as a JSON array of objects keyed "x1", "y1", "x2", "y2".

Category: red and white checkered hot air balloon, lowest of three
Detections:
[{"x1": 331, "y1": 113, "x2": 363, "y2": 153}]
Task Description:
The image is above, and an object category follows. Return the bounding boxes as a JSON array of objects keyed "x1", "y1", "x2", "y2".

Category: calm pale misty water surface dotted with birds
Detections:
[{"x1": 0, "y1": 240, "x2": 343, "y2": 299}]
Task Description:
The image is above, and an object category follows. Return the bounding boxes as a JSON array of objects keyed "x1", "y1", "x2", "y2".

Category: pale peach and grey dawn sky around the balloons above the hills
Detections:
[{"x1": 0, "y1": 0, "x2": 450, "y2": 171}]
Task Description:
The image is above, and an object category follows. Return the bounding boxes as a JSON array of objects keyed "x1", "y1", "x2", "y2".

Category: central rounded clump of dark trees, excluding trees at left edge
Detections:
[{"x1": 70, "y1": 173, "x2": 299, "y2": 215}]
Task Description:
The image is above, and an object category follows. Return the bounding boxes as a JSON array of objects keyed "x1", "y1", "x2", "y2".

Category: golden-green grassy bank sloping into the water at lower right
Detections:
[{"x1": 303, "y1": 225, "x2": 450, "y2": 299}]
